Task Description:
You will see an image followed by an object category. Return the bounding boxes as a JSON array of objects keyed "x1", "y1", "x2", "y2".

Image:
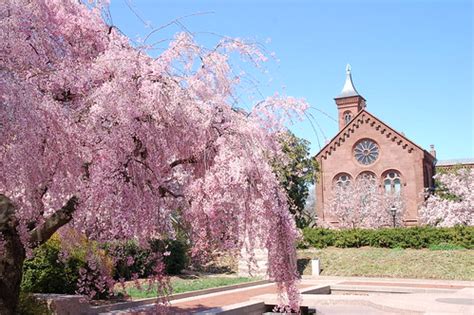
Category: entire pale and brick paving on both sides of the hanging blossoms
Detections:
[{"x1": 104, "y1": 276, "x2": 474, "y2": 315}]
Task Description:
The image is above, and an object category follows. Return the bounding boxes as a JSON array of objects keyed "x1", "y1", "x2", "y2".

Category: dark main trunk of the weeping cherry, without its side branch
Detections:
[{"x1": 0, "y1": 194, "x2": 25, "y2": 315}]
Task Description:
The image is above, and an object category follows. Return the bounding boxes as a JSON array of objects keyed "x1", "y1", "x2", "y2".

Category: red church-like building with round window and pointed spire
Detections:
[{"x1": 315, "y1": 65, "x2": 436, "y2": 226}]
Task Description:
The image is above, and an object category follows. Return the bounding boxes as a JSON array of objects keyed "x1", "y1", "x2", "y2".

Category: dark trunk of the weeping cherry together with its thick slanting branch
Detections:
[{"x1": 0, "y1": 194, "x2": 78, "y2": 315}]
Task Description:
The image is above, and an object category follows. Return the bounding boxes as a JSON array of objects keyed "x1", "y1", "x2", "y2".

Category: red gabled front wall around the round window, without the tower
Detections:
[{"x1": 315, "y1": 115, "x2": 427, "y2": 225}]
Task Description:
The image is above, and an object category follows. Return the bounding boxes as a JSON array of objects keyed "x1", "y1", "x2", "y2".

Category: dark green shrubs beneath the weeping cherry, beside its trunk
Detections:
[{"x1": 21, "y1": 232, "x2": 188, "y2": 299}]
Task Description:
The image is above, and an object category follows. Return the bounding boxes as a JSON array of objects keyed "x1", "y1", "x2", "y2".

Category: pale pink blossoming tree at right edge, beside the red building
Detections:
[{"x1": 420, "y1": 168, "x2": 474, "y2": 226}]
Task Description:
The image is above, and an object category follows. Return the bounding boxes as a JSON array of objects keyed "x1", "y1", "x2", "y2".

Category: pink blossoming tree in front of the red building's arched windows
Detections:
[{"x1": 325, "y1": 176, "x2": 404, "y2": 228}]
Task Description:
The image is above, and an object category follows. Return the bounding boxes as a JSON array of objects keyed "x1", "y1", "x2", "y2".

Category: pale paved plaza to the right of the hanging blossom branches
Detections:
[{"x1": 255, "y1": 277, "x2": 474, "y2": 315}]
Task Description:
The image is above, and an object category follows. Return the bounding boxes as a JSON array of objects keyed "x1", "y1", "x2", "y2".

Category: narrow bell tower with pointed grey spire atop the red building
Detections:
[{"x1": 334, "y1": 64, "x2": 365, "y2": 130}]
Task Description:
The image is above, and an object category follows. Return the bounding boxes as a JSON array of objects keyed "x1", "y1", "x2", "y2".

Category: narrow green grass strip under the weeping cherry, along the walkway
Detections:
[{"x1": 122, "y1": 277, "x2": 256, "y2": 299}]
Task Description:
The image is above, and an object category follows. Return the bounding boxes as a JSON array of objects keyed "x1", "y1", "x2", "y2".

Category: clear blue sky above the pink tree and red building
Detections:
[{"x1": 110, "y1": 0, "x2": 474, "y2": 160}]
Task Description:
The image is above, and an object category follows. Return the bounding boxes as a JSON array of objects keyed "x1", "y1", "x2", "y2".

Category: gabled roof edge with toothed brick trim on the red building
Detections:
[{"x1": 315, "y1": 109, "x2": 434, "y2": 159}]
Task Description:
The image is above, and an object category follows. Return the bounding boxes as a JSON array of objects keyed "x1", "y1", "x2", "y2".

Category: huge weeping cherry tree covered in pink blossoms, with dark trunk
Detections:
[{"x1": 0, "y1": 0, "x2": 307, "y2": 314}]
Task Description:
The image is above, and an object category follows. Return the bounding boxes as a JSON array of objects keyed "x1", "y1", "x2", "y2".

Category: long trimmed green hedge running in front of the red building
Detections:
[{"x1": 298, "y1": 226, "x2": 474, "y2": 249}]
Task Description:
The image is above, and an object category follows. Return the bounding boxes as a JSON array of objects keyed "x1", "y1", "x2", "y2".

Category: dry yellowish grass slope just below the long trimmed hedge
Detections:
[{"x1": 298, "y1": 246, "x2": 474, "y2": 281}]
